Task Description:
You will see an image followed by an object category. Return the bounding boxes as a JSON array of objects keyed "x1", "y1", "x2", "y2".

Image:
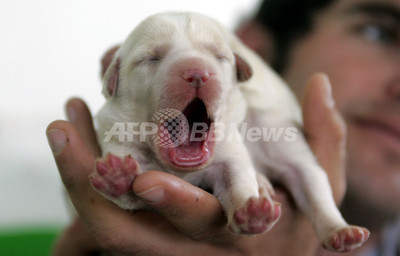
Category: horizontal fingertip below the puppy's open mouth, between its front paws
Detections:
[{"x1": 133, "y1": 171, "x2": 233, "y2": 241}]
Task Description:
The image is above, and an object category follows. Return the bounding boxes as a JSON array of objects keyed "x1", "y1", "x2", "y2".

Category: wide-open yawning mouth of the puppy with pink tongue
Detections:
[{"x1": 159, "y1": 98, "x2": 214, "y2": 169}]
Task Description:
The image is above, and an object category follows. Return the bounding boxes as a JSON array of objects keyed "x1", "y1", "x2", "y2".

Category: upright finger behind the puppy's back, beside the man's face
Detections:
[{"x1": 303, "y1": 73, "x2": 346, "y2": 202}]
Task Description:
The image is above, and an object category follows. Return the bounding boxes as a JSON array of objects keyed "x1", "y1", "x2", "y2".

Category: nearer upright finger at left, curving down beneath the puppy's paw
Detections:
[{"x1": 47, "y1": 121, "x2": 212, "y2": 255}]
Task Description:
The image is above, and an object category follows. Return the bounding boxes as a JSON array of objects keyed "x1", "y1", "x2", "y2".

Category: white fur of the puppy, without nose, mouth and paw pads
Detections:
[{"x1": 97, "y1": 13, "x2": 368, "y2": 250}]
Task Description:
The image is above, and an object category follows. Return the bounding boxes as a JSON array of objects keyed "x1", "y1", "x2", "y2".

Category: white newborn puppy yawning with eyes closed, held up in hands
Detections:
[{"x1": 90, "y1": 13, "x2": 369, "y2": 252}]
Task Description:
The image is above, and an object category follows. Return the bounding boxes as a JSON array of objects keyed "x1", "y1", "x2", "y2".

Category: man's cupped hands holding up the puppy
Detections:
[{"x1": 47, "y1": 62, "x2": 345, "y2": 256}]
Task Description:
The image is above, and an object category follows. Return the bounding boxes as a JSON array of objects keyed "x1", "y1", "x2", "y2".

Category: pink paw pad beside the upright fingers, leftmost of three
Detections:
[{"x1": 89, "y1": 154, "x2": 139, "y2": 197}]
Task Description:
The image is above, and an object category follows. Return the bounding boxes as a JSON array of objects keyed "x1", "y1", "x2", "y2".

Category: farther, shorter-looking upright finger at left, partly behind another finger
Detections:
[{"x1": 66, "y1": 98, "x2": 101, "y2": 156}]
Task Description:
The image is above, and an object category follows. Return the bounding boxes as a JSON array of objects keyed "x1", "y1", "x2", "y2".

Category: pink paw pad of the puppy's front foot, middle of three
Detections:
[{"x1": 231, "y1": 197, "x2": 281, "y2": 235}]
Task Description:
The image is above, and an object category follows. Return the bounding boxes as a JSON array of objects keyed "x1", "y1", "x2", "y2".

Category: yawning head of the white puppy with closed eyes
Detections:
[{"x1": 103, "y1": 13, "x2": 252, "y2": 171}]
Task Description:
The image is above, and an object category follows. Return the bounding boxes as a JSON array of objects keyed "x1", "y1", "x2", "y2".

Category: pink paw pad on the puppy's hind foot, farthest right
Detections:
[{"x1": 324, "y1": 226, "x2": 370, "y2": 252}]
